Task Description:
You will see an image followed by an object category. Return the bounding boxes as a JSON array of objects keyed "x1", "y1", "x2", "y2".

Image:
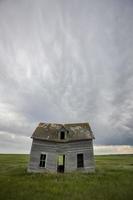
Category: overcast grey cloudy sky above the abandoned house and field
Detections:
[{"x1": 0, "y1": 0, "x2": 133, "y2": 152}]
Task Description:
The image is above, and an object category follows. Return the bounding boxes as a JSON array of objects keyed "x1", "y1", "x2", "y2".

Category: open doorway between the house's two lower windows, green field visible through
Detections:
[{"x1": 57, "y1": 155, "x2": 65, "y2": 173}]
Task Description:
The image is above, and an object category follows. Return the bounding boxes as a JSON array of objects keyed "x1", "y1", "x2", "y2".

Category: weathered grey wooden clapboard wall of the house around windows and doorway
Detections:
[{"x1": 28, "y1": 140, "x2": 94, "y2": 172}]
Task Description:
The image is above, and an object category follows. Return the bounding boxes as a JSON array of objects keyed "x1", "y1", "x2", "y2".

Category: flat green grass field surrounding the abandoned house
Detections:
[{"x1": 0, "y1": 154, "x2": 133, "y2": 200}]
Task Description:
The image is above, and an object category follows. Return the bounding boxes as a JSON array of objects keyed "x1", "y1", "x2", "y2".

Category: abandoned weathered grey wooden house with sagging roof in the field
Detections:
[{"x1": 28, "y1": 123, "x2": 95, "y2": 172}]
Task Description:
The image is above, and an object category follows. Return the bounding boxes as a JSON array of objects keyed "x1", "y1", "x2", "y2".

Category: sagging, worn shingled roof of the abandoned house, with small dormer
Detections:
[{"x1": 32, "y1": 123, "x2": 94, "y2": 142}]
